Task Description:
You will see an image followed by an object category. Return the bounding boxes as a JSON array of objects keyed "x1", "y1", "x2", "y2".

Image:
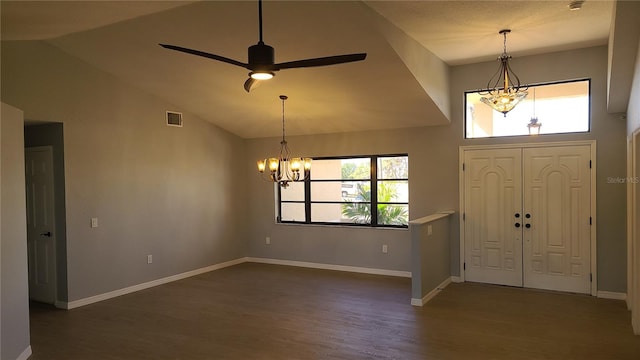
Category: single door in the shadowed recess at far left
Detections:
[{"x1": 25, "y1": 147, "x2": 56, "y2": 304}]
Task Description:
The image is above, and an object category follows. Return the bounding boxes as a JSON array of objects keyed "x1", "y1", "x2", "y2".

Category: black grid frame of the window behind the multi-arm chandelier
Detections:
[{"x1": 276, "y1": 153, "x2": 409, "y2": 229}]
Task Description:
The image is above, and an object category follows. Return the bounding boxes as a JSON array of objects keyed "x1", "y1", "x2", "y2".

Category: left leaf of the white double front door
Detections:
[{"x1": 464, "y1": 149, "x2": 522, "y2": 286}]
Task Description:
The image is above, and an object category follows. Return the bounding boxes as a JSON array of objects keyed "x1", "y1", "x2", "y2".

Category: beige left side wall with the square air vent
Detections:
[{"x1": 2, "y1": 42, "x2": 246, "y2": 301}]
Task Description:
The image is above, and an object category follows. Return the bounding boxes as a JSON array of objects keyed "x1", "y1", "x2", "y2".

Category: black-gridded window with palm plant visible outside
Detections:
[{"x1": 278, "y1": 154, "x2": 409, "y2": 227}]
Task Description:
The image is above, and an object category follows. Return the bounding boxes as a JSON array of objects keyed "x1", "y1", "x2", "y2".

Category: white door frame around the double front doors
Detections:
[{"x1": 458, "y1": 140, "x2": 598, "y2": 296}]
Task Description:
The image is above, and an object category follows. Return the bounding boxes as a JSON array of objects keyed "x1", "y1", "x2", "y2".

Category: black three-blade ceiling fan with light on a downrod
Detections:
[{"x1": 160, "y1": 0, "x2": 367, "y2": 92}]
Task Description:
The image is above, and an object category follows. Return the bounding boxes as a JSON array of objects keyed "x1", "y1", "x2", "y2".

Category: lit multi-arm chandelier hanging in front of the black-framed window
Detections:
[{"x1": 257, "y1": 95, "x2": 311, "y2": 188}]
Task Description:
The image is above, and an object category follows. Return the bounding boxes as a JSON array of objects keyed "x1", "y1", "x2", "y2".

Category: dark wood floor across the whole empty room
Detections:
[{"x1": 30, "y1": 263, "x2": 640, "y2": 360}]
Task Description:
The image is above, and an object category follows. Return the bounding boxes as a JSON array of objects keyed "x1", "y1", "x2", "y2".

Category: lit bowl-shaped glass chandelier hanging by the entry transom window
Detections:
[{"x1": 480, "y1": 29, "x2": 528, "y2": 117}]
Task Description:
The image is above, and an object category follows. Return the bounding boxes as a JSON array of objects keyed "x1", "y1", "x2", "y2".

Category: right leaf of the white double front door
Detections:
[{"x1": 523, "y1": 146, "x2": 591, "y2": 293}]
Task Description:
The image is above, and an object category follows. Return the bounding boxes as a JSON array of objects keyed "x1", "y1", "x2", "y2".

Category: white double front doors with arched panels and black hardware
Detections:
[{"x1": 463, "y1": 145, "x2": 591, "y2": 293}]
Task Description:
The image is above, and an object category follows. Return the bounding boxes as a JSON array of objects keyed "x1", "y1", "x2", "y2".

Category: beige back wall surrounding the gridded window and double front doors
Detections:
[{"x1": 246, "y1": 46, "x2": 626, "y2": 292}]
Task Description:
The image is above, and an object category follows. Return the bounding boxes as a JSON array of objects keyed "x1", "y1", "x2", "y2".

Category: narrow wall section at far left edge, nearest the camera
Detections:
[{"x1": 0, "y1": 102, "x2": 31, "y2": 360}]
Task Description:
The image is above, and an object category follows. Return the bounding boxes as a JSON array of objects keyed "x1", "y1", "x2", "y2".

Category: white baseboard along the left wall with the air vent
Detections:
[{"x1": 62, "y1": 258, "x2": 247, "y2": 310}]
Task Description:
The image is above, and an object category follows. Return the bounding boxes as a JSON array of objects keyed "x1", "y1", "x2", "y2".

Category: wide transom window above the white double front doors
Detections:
[{"x1": 465, "y1": 80, "x2": 591, "y2": 139}]
